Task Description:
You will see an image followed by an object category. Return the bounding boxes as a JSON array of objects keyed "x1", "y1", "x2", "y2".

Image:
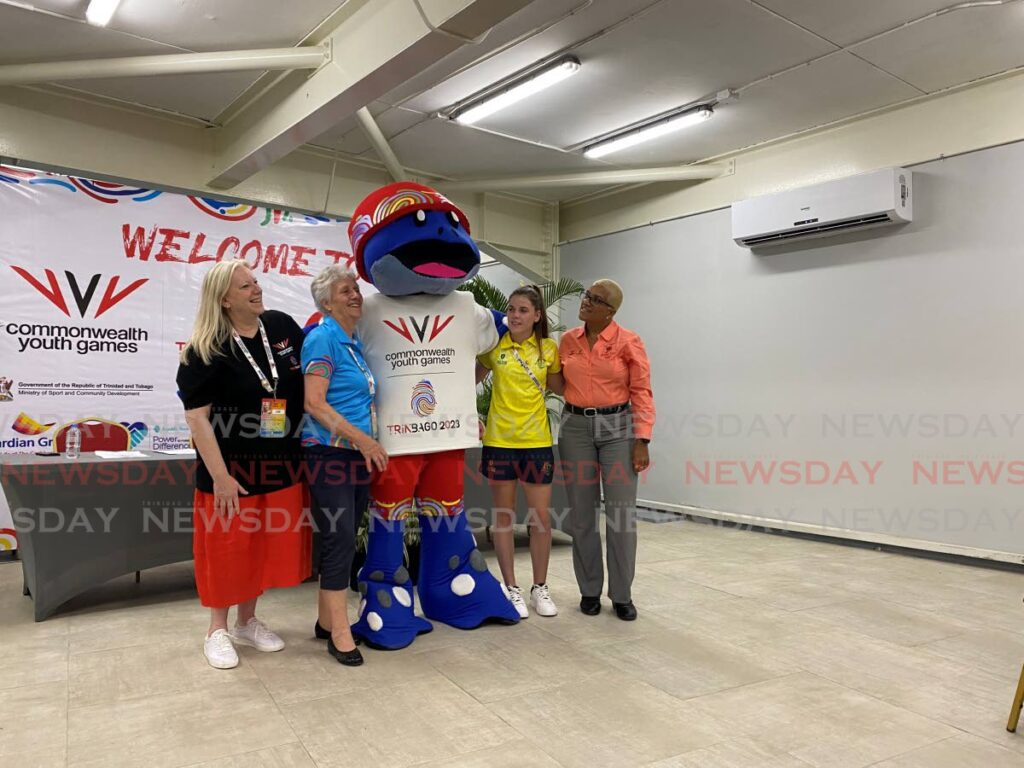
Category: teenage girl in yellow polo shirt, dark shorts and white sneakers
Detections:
[{"x1": 476, "y1": 286, "x2": 562, "y2": 618}]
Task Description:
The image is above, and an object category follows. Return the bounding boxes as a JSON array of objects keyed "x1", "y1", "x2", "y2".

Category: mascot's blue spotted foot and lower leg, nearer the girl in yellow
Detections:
[{"x1": 418, "y1": 512, "x2": 519, "y2": 630}]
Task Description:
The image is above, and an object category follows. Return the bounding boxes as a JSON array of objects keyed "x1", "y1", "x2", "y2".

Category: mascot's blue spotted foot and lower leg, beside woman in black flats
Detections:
[{"x1": 352, "y1": 515, "x2": 433, "y2": 650}]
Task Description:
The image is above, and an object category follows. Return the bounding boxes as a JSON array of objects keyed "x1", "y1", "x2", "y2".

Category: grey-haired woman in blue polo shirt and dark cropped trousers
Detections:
[{"x1": 302, "y1": 265, "x2": 387, "y2": 667}]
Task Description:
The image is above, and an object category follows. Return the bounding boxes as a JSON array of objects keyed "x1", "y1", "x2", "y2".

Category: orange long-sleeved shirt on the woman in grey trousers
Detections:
[{"x1": 558, "y1": 322, "x2": 654, "y2": 440}]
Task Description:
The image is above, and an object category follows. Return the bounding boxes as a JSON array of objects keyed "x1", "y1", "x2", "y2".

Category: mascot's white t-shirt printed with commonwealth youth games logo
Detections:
[{"x1": 358, "y1": 291, "x2": 498, "y2": 456}]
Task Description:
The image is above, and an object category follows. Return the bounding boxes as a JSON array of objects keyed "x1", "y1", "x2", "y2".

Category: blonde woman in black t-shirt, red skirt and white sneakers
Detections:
[{"x1": 177, "y1": 261, "x2": 311, "y2": 669}]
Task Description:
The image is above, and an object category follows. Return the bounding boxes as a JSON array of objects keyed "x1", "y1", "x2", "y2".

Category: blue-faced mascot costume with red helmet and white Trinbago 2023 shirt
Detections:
[{"x1": 348, "y1": 181, "x2": 519, "y2": 649}]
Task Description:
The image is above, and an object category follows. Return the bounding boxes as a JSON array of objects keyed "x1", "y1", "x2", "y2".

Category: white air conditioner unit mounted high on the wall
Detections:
[{"x1": 732, "y1": 168, "x2": 913, "y2": 248}]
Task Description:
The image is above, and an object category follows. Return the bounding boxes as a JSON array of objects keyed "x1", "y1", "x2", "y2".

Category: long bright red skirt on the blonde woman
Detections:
[{"x1": 193, "y1": 483, "x2": 312, "y2": 608}]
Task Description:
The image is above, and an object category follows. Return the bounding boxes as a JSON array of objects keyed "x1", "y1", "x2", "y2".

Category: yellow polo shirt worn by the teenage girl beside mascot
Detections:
[{"x1": 478, "y1": 333, "x2": 562, "y2": 449}]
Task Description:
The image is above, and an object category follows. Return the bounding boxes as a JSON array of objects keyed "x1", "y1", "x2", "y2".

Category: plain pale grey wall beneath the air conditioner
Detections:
[{"x1": 561, "y1": 143, "x2": 1024, "y2": 562}]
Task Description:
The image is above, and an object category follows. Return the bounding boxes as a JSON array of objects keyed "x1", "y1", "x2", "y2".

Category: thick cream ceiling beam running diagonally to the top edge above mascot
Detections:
[{"x1": 209, "y1": 0, "x2": 531, "y2": 189}]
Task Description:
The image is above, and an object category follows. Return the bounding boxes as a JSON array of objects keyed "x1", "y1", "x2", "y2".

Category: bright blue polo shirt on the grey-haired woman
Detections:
[{"x1": 302, "y1": 317, "x2": 377, "y2": 449}]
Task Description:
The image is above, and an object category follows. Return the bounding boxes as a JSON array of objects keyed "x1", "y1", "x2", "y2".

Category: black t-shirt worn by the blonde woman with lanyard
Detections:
[{"x1": 177, "y1": 309, "x2": 304, "y2": 496}]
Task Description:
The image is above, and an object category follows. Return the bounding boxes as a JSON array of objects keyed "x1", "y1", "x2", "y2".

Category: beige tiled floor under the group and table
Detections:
[{"x1": 0, "y1": 521, "x2": 1024, "y2": 768}]
